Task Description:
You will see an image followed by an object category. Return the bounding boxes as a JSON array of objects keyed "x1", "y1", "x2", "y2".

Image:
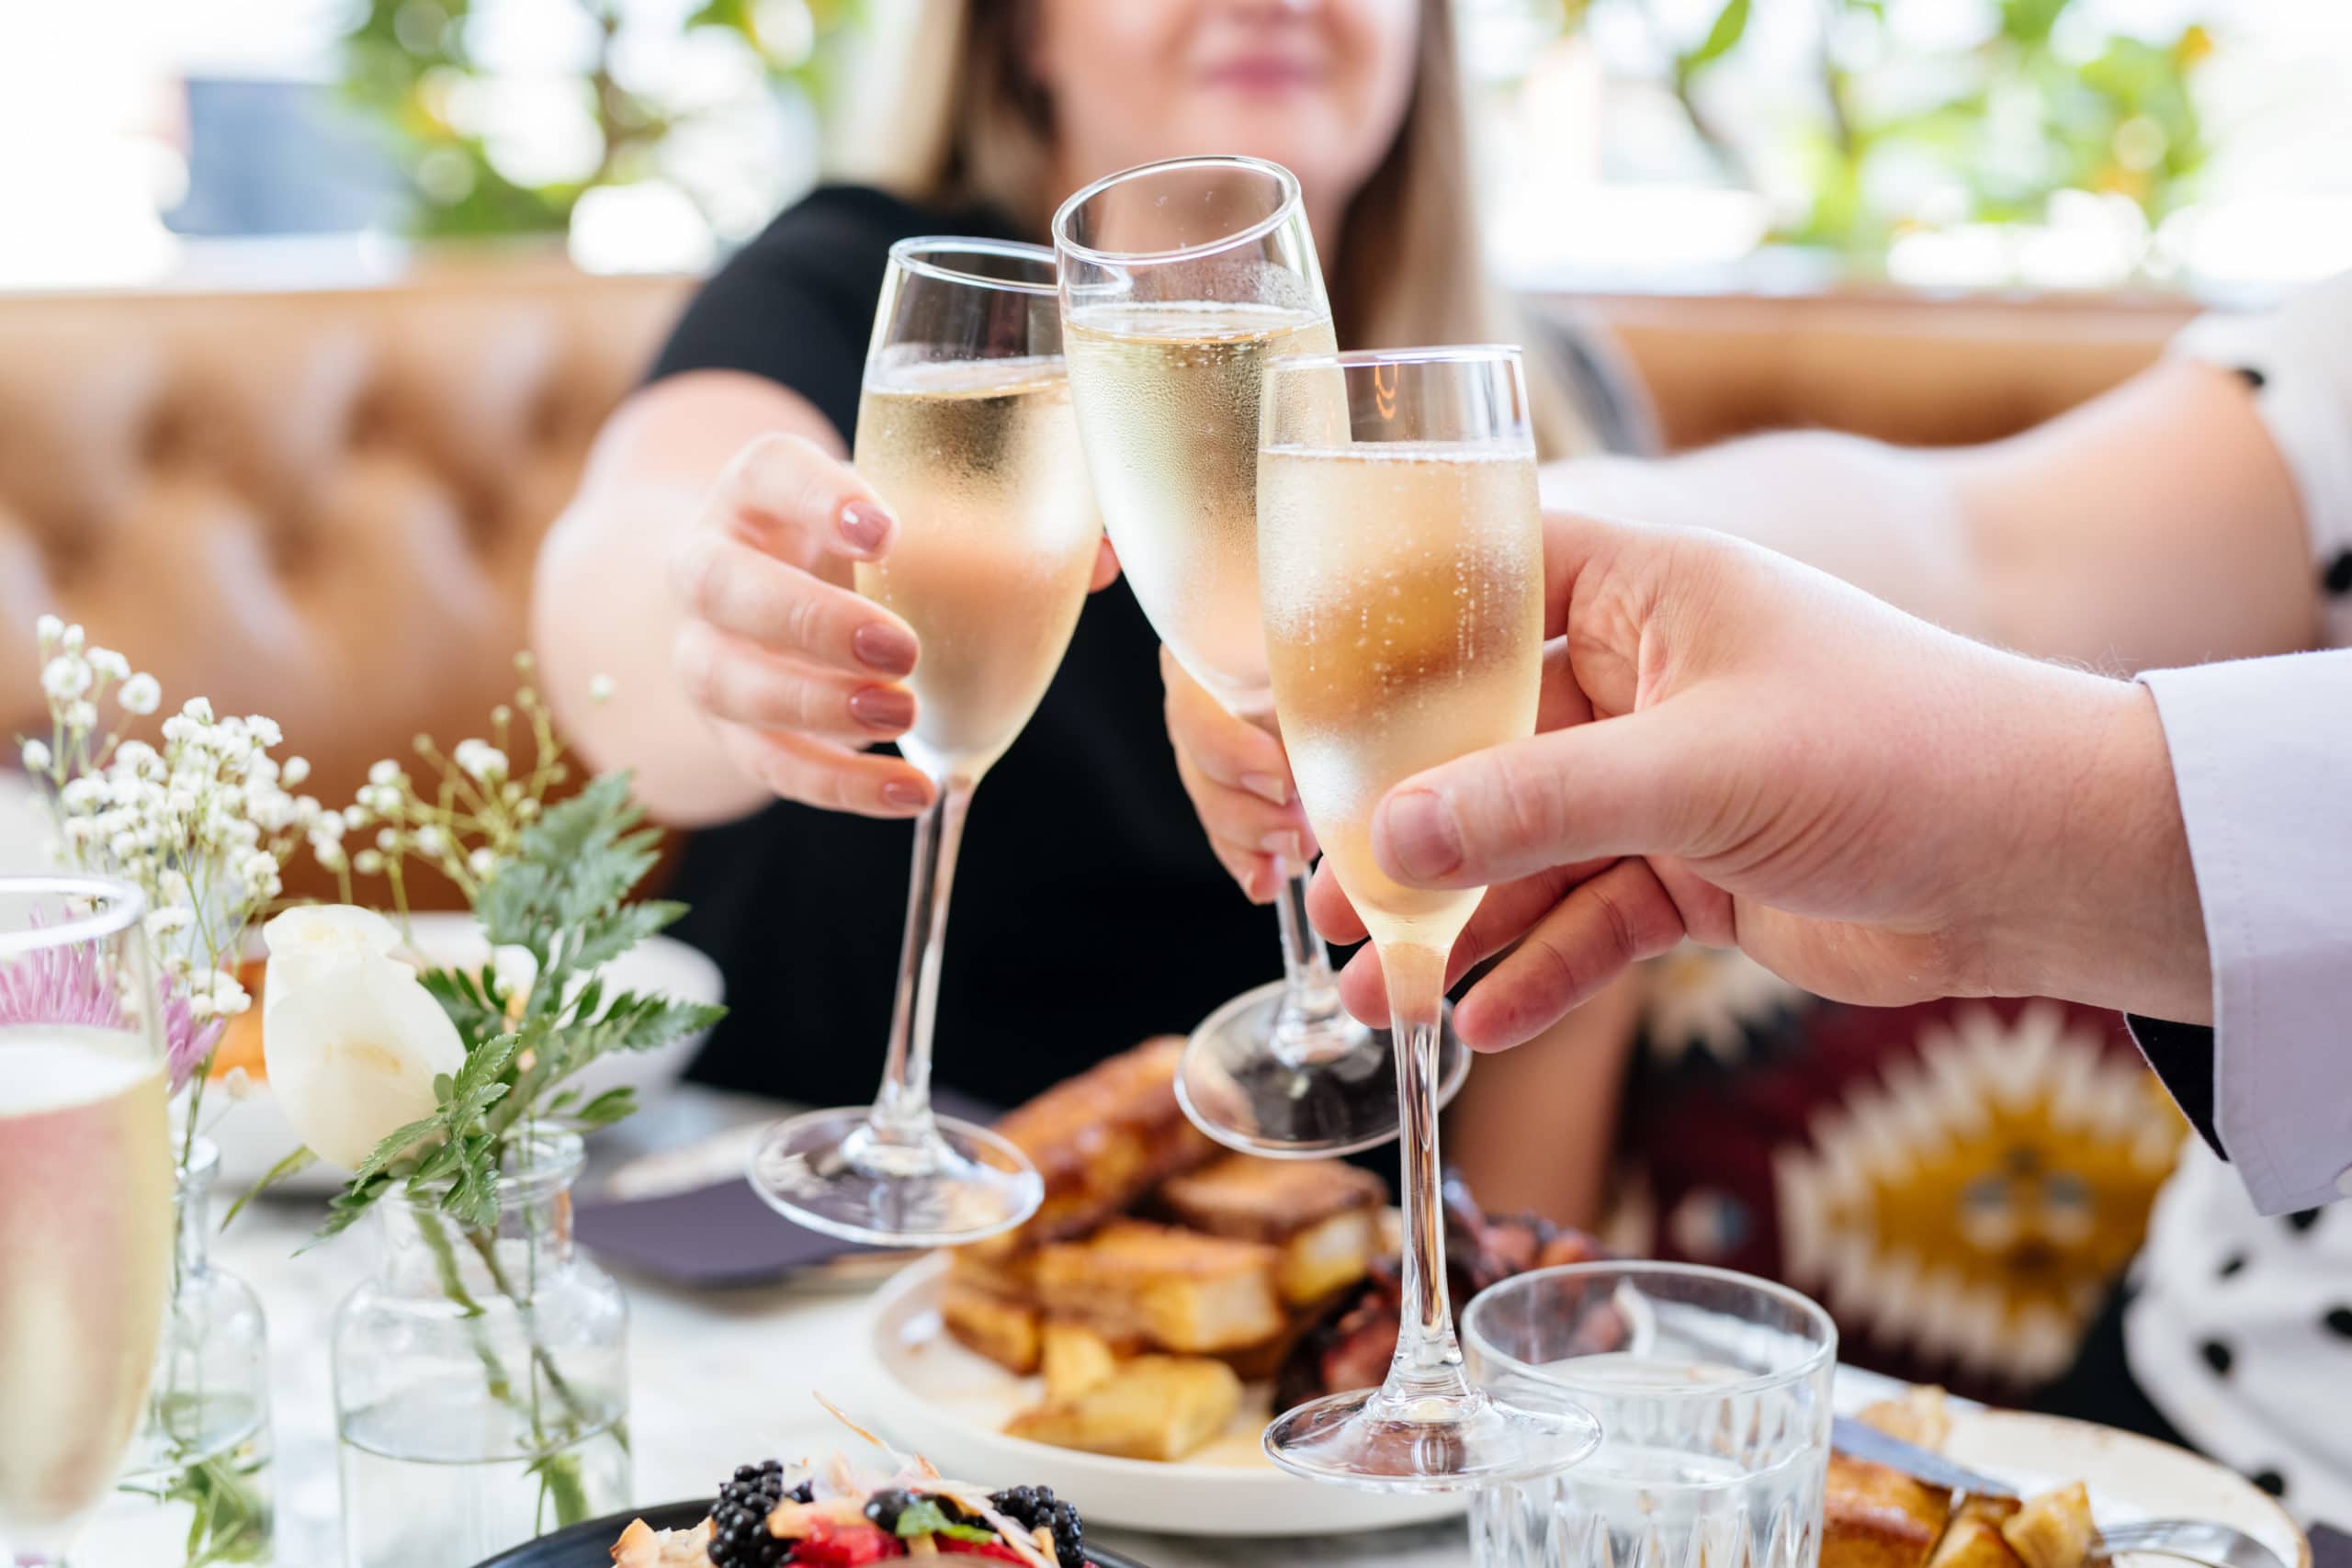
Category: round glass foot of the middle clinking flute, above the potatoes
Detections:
[{"x1": 1176, "y1": 980, "x2": 1470, "y2": 1159}]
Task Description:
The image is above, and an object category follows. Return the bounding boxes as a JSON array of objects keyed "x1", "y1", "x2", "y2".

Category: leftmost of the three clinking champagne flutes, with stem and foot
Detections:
[{"x1": 751, "y1": 237, "x2": 1103, "y2": 1246}]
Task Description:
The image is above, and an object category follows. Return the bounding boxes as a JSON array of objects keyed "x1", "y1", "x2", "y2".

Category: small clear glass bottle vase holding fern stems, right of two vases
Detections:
[{"x1": 329, "y1": 1134, "x2": 630, "y2": 1568}]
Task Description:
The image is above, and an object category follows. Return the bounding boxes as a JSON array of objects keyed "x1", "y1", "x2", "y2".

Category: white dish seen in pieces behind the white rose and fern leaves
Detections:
[{"x1": 209, "y1": 915, "x2": 727, "y2": 1197}]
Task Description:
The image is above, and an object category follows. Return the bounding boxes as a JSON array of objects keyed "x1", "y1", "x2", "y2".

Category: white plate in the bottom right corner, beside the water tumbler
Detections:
[{"x1": 1943, "y1": 1411, "x2": 2312, "y2": 1568}]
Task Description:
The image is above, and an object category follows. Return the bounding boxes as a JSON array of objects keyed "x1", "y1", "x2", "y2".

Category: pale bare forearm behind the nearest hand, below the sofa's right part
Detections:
[{"x1": 1543, "y1": 430, "x2": 1999, "y2": 637}]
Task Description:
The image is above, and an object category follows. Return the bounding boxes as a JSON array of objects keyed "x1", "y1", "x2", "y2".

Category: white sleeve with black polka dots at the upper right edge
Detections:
[{"x1": 2171, "y1": 273, "x2": 2352, "y2": 647}]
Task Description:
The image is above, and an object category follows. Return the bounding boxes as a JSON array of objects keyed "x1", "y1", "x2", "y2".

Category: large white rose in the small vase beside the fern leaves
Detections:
[{"x1": 261, "y1": 905, "x2": 466, "y2": 1170}]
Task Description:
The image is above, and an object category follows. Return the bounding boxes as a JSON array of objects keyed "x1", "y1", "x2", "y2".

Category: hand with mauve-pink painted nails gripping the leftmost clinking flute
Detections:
[{"x1": 671, "y1": 434, "x2": 933, "y2": 816}]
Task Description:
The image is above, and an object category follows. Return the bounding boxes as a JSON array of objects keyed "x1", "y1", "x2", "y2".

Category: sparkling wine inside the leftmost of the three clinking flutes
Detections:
[{"x1": 856, "y1": 357, "x2": 1101, "y2": 783}]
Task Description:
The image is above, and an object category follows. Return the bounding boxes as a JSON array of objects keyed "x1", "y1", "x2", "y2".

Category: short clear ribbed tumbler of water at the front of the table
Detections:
[{"x1": 1463, "y1": 1262, "x2": 1837, "y2": 1568}]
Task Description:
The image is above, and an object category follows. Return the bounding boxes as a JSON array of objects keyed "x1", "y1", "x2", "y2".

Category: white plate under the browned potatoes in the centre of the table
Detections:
[{"x1": 861, "y1": 1258, "x2": 1467, "y2": 1535}]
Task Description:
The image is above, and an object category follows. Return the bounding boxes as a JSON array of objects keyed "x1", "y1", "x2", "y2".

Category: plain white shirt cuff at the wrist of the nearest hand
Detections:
[{"x1": 2141, "y1": 649, "x2": 2352, "y2": 1213}]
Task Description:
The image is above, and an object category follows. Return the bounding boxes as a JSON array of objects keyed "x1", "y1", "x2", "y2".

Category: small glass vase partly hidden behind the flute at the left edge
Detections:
[{"x1": 75, "y1": 1138, "x2": 273, "y2": 1568}]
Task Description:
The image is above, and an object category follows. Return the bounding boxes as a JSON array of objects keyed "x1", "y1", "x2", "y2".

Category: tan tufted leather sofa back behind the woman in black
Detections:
[{"x1": 0, "y1": 259, "x2": 2180, "y2": 893}]
